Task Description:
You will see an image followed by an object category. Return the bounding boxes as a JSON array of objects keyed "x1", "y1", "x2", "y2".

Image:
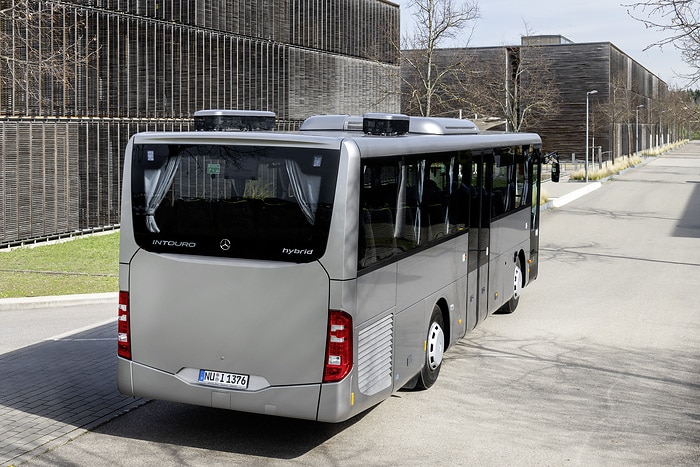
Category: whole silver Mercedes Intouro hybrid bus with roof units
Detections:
[{"x1": 117, "y1": 110, "x2": 542, "y2": 422}]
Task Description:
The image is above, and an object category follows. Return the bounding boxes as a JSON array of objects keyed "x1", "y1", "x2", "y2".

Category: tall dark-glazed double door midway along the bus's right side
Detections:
[{"x1": 468, "y1": 154, "x2": 493, "y2": 322}]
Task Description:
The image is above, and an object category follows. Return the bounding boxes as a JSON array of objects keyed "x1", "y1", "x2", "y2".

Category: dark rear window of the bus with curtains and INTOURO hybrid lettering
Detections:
[{"x1": 131, "y1": 144, "x2": 339, "y2": 262}]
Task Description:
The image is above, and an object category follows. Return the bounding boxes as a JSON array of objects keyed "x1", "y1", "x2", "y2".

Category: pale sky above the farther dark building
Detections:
[{"x1": 390, "y1": 0, "x2": 690, "y2": 88}]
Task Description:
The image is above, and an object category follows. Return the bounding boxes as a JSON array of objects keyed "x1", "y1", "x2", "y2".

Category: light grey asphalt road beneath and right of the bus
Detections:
[{"x1": 17, "y1": 143, "x2": 700, "y2": 466}]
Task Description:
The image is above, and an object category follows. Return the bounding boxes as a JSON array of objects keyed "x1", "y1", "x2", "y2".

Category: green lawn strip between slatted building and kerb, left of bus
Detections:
[{"x1": 0, "y1": 232, "x2": 119, "y2": 298}]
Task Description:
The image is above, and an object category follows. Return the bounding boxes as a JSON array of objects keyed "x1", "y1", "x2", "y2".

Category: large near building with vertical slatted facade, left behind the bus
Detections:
[{"x1": 0, "y1": 0, "x2": 399, "y2": 246}]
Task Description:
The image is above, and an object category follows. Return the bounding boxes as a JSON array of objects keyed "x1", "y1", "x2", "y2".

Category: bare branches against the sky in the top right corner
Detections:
[{"x1": 624, "y1": 0, "x2": 700, "y2": 83}]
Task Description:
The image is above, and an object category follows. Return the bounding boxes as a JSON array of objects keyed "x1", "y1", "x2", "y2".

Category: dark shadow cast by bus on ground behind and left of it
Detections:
[{"x1": 0, "y1": 323, "x2": 367, "y2": 459}]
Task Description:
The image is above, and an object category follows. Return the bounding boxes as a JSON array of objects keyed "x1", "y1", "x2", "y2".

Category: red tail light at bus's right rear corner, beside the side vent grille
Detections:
[{"x1": 323, "y1": 310, "x2": 352, "y2": 383}]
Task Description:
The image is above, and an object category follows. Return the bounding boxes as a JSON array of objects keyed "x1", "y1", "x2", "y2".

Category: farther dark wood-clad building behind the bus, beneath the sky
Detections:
[{"x1": 402, "y1": 36, "x2": 674, "y2": 160}]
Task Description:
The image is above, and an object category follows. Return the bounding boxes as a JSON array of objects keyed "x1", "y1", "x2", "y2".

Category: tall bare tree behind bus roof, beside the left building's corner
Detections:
[{"x1": 401, "y1": 0, "x2": 479, "y2": 116}]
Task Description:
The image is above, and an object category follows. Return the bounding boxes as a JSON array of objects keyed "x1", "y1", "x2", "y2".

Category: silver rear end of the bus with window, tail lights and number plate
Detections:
[{"x1": 118, "y1": 124, "x2": 356, "y2": 421}]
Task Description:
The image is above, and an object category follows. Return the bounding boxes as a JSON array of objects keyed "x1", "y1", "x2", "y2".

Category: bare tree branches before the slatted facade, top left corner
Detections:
[{"x1": 0, "y1": 0, "x2": 96, "y2": 113}]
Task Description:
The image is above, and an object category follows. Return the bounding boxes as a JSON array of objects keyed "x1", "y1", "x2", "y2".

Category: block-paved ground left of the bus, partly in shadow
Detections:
[{"x1": 0, "y1": 308, "x2": 145, "y2": 466}]
